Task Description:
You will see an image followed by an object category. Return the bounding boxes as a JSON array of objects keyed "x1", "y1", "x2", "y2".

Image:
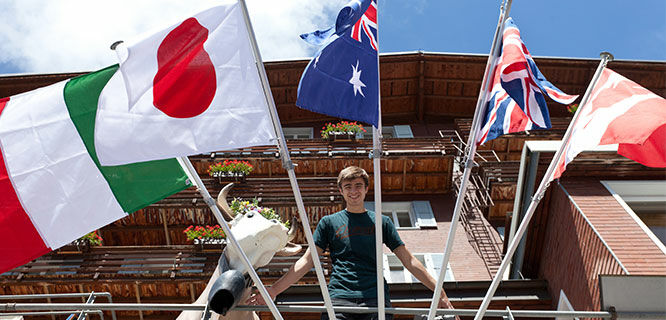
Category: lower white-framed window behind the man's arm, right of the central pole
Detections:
[{"x1": 384, "y1": 253, "x2": 455, "y2": 283}]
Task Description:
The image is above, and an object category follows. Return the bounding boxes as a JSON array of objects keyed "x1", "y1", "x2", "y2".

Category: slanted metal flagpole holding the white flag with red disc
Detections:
[{"x1": 239, "y1": 0, "x2": 335, "y2": 319}]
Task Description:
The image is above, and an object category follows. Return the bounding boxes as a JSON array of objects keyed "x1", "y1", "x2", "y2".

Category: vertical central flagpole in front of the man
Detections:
[{"x1": 372, "y1": 1, "x2": 386, "y2": 319}]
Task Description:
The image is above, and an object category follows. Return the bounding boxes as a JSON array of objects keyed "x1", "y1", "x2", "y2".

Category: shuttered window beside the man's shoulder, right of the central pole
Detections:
[{"x1": 365, "y1": 201, "x2": 437, "y2": 230}]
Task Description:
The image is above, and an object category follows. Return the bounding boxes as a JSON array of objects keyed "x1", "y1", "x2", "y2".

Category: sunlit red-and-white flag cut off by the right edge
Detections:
[{"x1": 553, "y1": 68, "x2": 666, "y2": 179}]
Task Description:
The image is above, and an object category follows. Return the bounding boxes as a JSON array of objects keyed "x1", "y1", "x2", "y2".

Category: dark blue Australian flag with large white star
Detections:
[{"x1": 296, "y1": 0, "x2": 379, "y2": 127}]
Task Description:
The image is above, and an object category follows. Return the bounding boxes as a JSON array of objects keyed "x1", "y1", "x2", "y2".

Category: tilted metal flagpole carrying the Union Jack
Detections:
[{"x1": 428, "y1": 0, "x2": 513, "y2": 320}]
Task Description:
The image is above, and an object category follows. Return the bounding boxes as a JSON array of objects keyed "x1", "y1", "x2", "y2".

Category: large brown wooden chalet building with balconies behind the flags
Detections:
[{"x1": 0, "y1": 52, "x2": 666, "y2": 320}]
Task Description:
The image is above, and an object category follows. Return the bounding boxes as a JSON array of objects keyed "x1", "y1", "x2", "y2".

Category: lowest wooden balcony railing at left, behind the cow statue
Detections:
[{"x1": 0, "y1": 245, "x2": 331, "y2": 284}]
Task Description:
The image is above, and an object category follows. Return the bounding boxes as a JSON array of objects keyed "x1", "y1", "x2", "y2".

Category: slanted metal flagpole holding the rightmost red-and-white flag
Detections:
[{"x1": 474, "y1": 52, "x2": 613, "y2": 320}]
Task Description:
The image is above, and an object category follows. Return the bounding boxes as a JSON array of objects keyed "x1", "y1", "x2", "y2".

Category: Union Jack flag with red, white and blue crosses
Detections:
[{"x1": 477, "y1": 18, "x2": 578, "y2": 144}]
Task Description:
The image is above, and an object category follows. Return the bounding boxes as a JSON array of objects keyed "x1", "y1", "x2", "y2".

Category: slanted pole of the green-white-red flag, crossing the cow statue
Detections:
[{"x1": 178, "y1": 157, "x2": 282, "y2": 319}]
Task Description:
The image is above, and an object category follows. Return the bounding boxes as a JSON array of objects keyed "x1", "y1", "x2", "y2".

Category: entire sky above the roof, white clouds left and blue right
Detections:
[{"x1": 0, "y1": 0, "x2": 666, "y2": 74}]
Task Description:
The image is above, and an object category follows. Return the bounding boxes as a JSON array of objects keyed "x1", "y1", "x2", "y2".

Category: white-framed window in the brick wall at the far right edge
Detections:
[{"x1": 601, "y1": 180, "x2": 666, "y2": 253}]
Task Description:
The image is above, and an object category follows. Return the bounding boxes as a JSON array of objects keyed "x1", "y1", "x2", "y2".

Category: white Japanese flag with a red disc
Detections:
[{"x1": 95, "y1": 0, "x2": 275, "y2": 165}]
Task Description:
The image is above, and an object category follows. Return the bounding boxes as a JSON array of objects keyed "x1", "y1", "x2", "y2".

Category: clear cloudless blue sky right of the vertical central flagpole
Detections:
[{"x1": 379, "y1": 0, "x2": 666, "y2": 60}]
